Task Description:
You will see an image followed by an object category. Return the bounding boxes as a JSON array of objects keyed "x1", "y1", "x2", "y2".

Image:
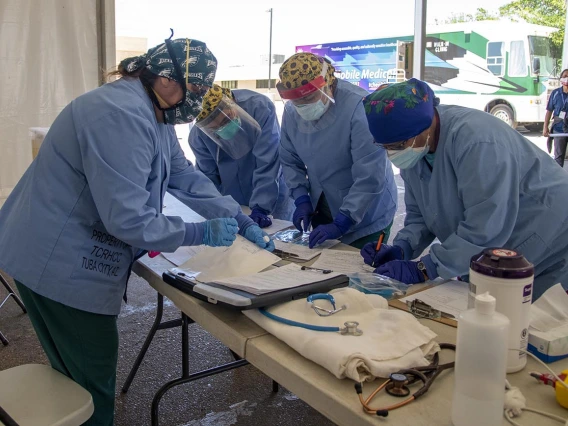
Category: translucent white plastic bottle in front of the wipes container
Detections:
[{"x1": 452, "y1": 293, "x2": 510, "y2": 426}]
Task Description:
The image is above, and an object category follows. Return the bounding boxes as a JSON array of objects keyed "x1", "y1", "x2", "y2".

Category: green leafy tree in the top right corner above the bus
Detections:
[{"x1": 499, "y1": 0, "x2": 566, "y2": 57}]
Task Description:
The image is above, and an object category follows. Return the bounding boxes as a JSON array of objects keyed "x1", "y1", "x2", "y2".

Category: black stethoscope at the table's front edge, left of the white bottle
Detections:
[{"x1": 355, "y1": 343, "x2": 456, "y2": 417}]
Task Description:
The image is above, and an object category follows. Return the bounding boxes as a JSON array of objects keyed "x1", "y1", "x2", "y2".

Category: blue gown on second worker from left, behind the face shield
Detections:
[{"x1": 189, "y1": 90, "x2": 292, "y2": 219}]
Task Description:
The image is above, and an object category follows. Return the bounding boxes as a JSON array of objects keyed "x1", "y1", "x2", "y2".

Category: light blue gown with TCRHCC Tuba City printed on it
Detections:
[{"x1": 0, "y1": 78, "x2": 240, "y2": 315}]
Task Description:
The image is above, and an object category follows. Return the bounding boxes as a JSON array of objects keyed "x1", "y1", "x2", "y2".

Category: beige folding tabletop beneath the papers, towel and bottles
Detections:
[{"x1": 134, "y1": 196, "x2": 568, "y2": 426}]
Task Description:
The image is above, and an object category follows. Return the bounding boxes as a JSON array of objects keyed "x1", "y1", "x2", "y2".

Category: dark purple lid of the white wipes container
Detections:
[{"x1": 469, "y1": 248, "x2": 534, "y2": 279}]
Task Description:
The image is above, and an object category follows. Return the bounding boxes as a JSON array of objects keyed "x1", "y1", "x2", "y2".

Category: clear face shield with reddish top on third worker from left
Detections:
[{"x1": 276, "y1": 61, "x2": 335, "y2": 121}]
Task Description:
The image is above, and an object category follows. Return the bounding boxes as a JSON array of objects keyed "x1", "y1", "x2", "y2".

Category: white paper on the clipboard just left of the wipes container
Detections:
[{"x1": 400, "y1": 281, "x2": 469, "y2": 320}]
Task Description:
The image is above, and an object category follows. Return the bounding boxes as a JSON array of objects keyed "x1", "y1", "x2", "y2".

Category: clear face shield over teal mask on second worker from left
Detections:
[{"x1": 195, "y1": 95, "x2": 261, "y2": 160}]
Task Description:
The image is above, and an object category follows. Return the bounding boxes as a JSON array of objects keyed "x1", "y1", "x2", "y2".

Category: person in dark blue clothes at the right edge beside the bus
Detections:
[{"x1": 542, "y1": 69, "x2": 568, "y2": 167}]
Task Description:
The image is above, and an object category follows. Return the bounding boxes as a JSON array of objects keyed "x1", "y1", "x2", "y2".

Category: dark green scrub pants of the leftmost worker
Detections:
[{"x1": 16, "y1": 281, "x2": 118, "y2": 426}]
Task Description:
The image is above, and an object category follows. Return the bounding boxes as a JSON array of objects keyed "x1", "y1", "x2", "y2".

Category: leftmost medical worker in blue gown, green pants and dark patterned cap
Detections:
[{"x1": 0, "y1": 39, "x2": 273, "y2": 426}]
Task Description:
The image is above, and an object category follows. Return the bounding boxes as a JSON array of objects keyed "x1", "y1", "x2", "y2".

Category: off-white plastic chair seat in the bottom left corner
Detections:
[{"x1": 0, "y1": 364, "x2": 95, "y2": 426}]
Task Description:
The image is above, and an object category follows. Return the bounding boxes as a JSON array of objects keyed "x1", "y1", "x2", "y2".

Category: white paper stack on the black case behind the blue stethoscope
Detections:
[{"x1": 215, "y1": 263, "x2": 341, "y2": 295}]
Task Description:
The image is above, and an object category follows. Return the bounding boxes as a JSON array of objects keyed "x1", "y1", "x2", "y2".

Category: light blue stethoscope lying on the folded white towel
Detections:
[{"x1": 258, "y1": 293, "x2": 363, "y2": 336}]
